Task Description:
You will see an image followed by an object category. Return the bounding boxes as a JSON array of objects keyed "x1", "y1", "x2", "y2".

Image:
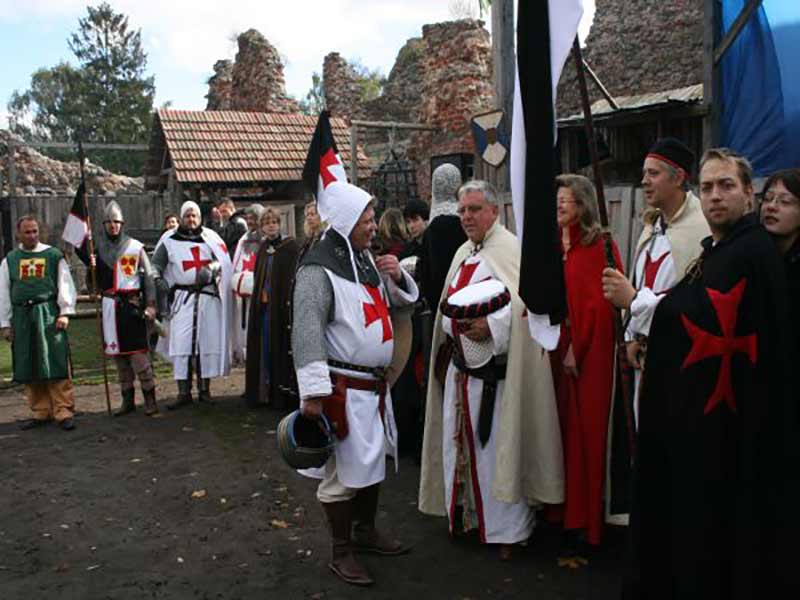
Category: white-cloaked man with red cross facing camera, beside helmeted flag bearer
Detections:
[{"x1": 152, "y1": 201, "x2": 232, "y2": 410}]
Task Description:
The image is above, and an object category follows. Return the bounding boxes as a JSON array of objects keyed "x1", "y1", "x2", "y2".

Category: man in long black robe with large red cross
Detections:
[{"x1": 625, "y1": 150, "x2": 800, "y2": 600}]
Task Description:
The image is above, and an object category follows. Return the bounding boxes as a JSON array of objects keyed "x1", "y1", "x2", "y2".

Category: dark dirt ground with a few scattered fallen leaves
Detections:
[{"x1": 0, "y1": 371, "x2": 624, "y2": 600}]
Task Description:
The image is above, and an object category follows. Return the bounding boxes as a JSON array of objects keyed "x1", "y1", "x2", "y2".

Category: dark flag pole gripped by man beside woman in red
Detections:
[{"x1": 572, "y1": 36, "x2": 636, "y2": 456}]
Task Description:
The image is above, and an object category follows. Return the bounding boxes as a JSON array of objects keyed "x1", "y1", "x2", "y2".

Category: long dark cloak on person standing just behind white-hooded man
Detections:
[{"x1": 245, "y1": 238, "x2": 300, "y2": 411}]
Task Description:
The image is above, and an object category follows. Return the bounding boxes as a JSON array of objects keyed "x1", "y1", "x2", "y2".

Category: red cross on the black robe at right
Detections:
[{"x1": 681, "y1": 278, "x2": 758, "y2": 415}]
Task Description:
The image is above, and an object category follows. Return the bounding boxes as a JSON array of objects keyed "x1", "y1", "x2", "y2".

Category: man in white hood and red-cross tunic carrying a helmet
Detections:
[{"x1": 292, "y1": 182, "x2": 418, "y2": 585}]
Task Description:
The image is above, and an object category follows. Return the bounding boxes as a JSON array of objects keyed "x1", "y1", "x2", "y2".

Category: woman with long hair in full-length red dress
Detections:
[{"x1": 551, "y1": 175, "x2": 622, "y2": 546}]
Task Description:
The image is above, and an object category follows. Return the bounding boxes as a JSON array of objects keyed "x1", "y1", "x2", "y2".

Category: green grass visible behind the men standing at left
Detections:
[{"x1": 0, "y1": 317, "x2": 172, "y2": 387}]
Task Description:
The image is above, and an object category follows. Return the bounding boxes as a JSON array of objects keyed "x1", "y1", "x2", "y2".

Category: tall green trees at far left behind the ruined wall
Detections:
[{"x1": 8, "y1": 2, "x2": 155, "y2": 175}]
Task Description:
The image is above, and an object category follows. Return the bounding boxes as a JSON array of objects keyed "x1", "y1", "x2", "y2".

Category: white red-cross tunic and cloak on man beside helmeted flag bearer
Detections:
[{"x1": 155, "y1": 228, "x2": 232, "y2": 379}]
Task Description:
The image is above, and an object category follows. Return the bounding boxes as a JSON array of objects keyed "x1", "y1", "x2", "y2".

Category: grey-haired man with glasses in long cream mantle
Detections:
[{"x1": 419, "y1": 181, "x2": 564, "y2": 559}]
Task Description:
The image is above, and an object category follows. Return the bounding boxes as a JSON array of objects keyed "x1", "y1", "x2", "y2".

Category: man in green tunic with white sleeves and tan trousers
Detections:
[{"x1": 0, "y1": 215, "x2": 77, "y2": 430}]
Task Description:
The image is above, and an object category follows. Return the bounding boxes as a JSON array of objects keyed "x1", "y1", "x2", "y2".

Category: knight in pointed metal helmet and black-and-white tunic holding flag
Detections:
[{"x1": 76, "y1": 200, "x2": 158, "y2": 416}]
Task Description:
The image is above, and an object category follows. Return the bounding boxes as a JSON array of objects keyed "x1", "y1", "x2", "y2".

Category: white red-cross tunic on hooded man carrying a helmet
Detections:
[{"x1": 297, "y1": 269, "x2": 418, "y2": 489}]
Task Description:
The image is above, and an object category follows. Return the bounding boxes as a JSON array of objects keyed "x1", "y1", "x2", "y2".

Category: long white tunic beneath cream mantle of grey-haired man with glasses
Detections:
[{"x1": 442, "y1": 255, "x2": 535, "y2": 544}]
